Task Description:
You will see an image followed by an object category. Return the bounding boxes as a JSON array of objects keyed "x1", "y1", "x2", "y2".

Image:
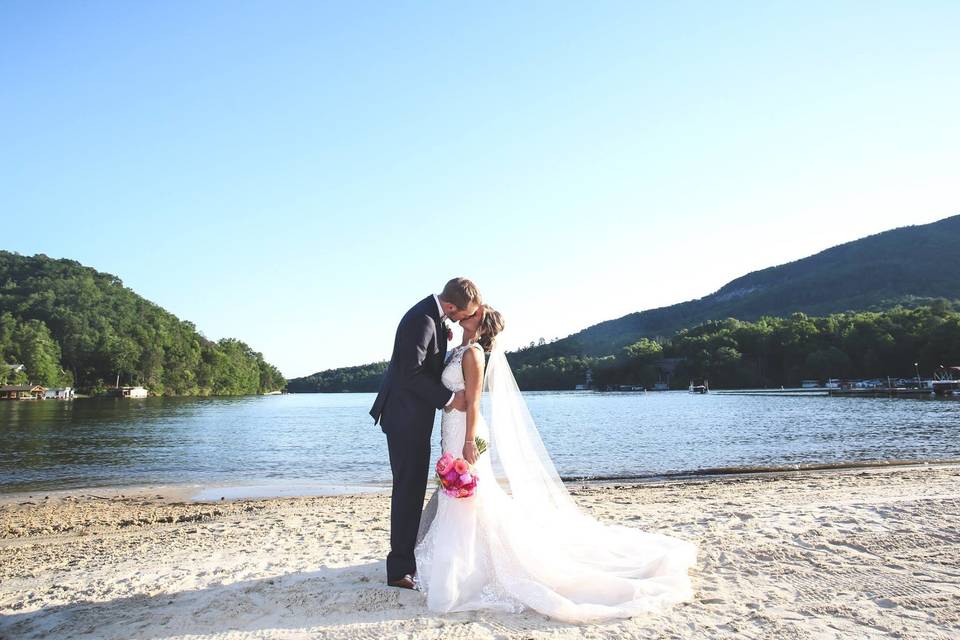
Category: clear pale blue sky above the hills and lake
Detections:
[{"x1": 0, "y1": 0, "x2": 960, "y2": 376}]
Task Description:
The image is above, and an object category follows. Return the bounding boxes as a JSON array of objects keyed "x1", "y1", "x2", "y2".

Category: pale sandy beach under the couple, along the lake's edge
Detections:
[{"x1": 0, "y1": 465, "x2": 960, "y2": 640}]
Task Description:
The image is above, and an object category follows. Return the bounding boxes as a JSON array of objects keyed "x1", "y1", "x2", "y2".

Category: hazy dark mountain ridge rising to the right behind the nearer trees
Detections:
[{"x1": 289, "y1": 215, "x2": 960, "y2": 391}]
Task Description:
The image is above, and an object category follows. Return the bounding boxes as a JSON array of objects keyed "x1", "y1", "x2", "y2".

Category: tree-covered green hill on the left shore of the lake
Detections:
[{"x1": 0, "y1": 251, "x2": 283, "y2": 395}]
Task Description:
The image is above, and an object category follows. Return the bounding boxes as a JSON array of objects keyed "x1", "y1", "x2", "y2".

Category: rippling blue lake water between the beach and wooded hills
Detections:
[{"x1": 0, "y1": 392, "x2": 960, "y2": 499}]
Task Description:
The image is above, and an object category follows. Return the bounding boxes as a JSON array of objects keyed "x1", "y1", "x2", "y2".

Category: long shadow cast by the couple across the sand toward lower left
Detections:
[{"x1": 0, "y1": 562, "x2": 572, "y2": 640}]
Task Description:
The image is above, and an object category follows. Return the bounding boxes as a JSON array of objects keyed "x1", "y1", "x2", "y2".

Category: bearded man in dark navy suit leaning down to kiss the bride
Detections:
[{"x1": 370, "y1": 278, "x2": 482, "y2": 589}]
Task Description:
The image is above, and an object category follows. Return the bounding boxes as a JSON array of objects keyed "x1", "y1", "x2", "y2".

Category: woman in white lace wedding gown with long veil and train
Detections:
[{"x1": 415, "y1": 305, "x2": 697, "y2": 623}]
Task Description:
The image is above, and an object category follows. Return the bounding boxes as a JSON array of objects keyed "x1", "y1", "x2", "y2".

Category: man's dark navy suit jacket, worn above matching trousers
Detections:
[{"x1": 370, "y1": 295, "x2": 451, "y2": 433}]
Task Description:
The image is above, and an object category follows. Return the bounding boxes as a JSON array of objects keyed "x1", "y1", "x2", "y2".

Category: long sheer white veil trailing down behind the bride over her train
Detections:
[{"x1": 481, "y1": 336, "x2": 697, "y2": 622}]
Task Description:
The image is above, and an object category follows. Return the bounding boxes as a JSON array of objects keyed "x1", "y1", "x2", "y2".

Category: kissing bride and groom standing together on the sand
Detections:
[{"x1": 370, "y1": 278, "x2": 697, "y2": 623}]
